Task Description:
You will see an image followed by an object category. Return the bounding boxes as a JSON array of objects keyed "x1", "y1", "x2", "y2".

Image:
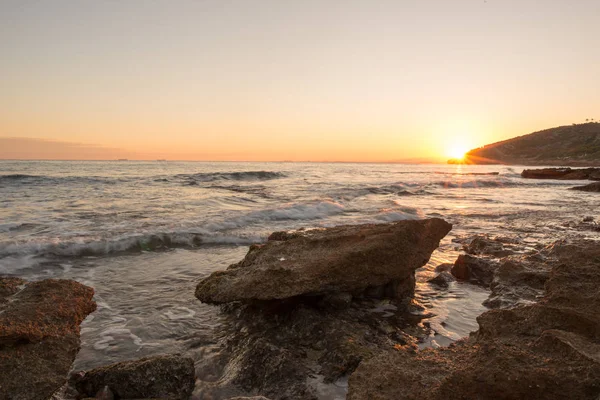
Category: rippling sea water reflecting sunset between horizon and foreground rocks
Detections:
[{"x1": 0, "y1": 161, "x2": 599, "y2": 399}]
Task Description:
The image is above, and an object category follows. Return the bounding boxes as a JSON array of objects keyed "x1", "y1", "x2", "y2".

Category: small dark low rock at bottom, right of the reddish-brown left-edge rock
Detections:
[{"x1": 69, "y1": 355, "x2": 195, "y2": 399}]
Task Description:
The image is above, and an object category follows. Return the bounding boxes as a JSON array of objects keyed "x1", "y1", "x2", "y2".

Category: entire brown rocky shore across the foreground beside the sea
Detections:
[{"x1": 0, "y1": 218, "x2": 600, "y2": 400}]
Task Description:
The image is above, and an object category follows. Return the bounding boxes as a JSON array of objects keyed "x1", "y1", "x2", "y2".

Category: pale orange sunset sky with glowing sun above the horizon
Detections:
[{"x1": 0, "y1": 0, "x2": 600, "y2": 162}]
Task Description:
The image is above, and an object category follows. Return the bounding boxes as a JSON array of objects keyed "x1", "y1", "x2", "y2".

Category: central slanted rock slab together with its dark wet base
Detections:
[{"x1": 196, "y1": 219, "x2": 451, "y2": 400}]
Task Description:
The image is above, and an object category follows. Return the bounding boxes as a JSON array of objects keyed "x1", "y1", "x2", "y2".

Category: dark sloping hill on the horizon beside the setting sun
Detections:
[{"x1": 448, "y1": 122, "x2": 600, "y2": 166}]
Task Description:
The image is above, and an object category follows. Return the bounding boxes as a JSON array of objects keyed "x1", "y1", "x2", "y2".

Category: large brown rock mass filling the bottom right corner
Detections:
[{"x1": 347, "y1": 241, "x2": 600, "y2": 400}]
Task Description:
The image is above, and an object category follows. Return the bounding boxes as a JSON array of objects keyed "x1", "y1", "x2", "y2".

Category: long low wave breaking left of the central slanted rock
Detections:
[{"x1": 0, "y1": 230, "x2": 264, "y2": 265}]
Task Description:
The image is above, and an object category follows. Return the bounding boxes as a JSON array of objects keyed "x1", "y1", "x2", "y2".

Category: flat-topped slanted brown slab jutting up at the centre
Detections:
[{"x1": 196, "y1": 218, "x2": 452, "y2": 304}]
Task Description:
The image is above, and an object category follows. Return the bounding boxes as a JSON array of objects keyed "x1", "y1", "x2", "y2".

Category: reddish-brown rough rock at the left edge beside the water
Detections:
[{"x1": 0, "y1": 278, "x2": 96, "y2": 399}]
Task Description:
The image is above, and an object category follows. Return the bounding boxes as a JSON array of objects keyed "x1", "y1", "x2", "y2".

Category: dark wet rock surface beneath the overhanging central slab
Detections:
[{"x1": 199, "y1": 298, "x2": 425, "y2": 400}]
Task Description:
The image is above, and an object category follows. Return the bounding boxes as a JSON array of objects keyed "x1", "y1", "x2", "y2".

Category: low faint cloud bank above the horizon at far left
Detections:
[{"x1": 0, "y1": 137, "x2": 133, "y2": 160}]
